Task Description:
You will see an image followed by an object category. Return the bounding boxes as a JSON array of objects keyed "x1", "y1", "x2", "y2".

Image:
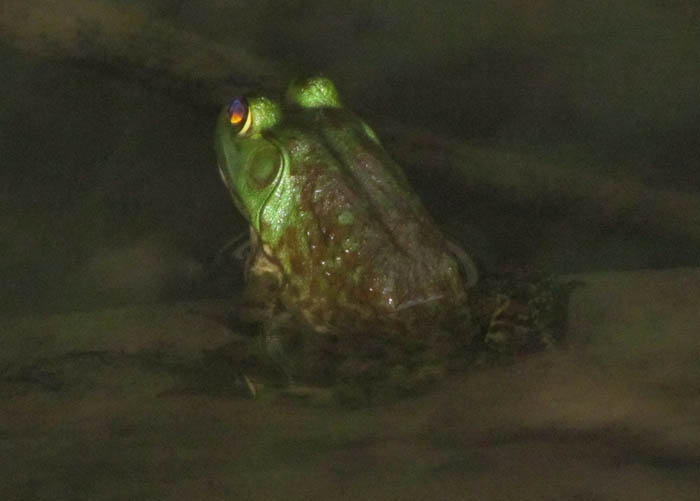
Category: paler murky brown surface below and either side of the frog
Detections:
[{"x1": 0, "y1": 270, "x2": 700, "y2": 500}]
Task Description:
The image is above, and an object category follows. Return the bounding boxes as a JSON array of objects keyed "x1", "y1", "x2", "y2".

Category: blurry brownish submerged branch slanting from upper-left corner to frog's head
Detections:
[{"x1": 0, "y1": 0, "x2": 285, "y2": 105}]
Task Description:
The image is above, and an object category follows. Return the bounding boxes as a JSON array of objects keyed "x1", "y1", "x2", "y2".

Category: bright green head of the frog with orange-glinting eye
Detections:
[{"x1": 216, "y1": 77, "x2": 386, "y2": 241}]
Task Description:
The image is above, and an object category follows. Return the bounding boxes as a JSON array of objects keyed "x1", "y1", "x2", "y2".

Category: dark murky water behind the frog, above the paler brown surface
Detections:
[{"x1": 0, "y1": 0, "x2": 700, "y2": 313}]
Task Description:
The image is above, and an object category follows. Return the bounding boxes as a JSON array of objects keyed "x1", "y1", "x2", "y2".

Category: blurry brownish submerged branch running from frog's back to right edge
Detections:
[{"x1": 381, "y1": 124, "x2": 700, "y2": 248}]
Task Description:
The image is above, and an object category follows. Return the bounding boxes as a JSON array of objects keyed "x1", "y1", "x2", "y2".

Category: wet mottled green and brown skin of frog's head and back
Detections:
[{"x1": 216, "y1": 78, "x2": 466, "y2": 332}]
